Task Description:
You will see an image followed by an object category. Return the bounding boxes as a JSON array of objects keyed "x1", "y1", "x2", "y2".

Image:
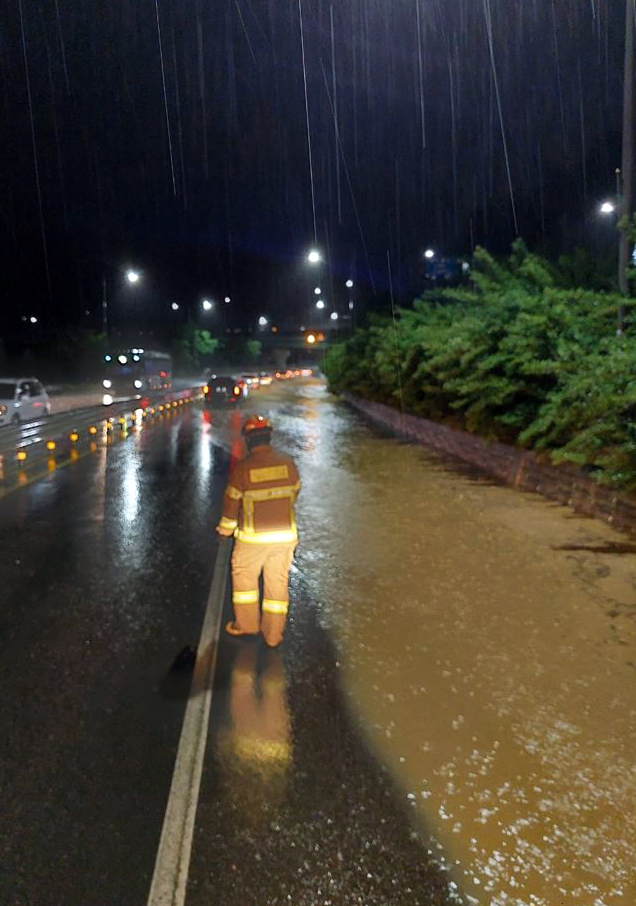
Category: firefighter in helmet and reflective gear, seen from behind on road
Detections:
[{"x1": 216, "y1": 415, "x2": 300, "y2": 648}]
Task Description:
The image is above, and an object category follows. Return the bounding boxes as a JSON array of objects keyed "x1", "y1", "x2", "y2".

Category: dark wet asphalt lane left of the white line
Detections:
[{"x1": 0, "y1": 413, "x2": 226, "y2": 906}]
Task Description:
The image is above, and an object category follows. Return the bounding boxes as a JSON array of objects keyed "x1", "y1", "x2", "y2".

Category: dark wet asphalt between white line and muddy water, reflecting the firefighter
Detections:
[{"x1": 186, "y1": 572, "x2": 459, "y2": 906}]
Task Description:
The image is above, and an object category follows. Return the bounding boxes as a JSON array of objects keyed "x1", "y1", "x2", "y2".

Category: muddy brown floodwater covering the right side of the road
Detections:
[{"x1": 238, "y1": 384, "x2": 636, "y2": 906}]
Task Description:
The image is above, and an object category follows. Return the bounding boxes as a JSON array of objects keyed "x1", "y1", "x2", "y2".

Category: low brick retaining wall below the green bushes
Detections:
[{"x1": 343, "y1": 393, "x2": 636, "y2": 534}]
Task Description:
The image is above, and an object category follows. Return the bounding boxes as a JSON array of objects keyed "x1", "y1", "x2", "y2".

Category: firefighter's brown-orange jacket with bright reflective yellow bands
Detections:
[{"x1": 219, "y1": 445, "x2": 300, "y2": 544}]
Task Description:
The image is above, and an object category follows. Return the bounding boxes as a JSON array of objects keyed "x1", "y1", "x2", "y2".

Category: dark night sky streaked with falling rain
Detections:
[{"x1": 0, "y1": 0, "x2": 624, "y2": 336}]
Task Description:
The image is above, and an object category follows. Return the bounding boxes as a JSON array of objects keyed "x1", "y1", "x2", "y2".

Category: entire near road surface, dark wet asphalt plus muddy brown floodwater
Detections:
[{"x1": 0, "y1": 382, "x2": 636, "y2": 906}]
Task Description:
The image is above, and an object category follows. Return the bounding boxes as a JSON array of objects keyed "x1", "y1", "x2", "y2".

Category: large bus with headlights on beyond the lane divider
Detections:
[{"x1": 102, "y1": 348, "x2": 172, "y2": 406}]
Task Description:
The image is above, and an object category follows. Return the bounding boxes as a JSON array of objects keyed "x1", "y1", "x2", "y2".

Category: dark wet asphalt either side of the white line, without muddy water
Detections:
[{"x1": 0, "y1": 396, "x2": 458, "y2": 906}]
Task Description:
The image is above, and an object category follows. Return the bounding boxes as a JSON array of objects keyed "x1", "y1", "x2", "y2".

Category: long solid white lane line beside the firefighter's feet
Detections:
[{"x1": 147, "y1": 540, "x2": 231, "y2": 906}]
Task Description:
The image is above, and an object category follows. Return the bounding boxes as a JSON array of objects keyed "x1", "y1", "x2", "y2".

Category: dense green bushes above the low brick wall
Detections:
[{"x1": 325, "y1": 241, "x2": 636, "y2": 489}]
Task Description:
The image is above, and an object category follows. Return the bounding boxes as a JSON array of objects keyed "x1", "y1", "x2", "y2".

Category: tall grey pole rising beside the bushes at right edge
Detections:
[{"x1": 616, "y1": 0, "x2": 634, "y2": 336}]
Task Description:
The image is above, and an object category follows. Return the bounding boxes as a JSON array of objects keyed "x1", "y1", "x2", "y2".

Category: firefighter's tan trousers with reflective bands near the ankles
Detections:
[{"x1": 232, "y1": 541, "x2": 296, "y2": 645}]
